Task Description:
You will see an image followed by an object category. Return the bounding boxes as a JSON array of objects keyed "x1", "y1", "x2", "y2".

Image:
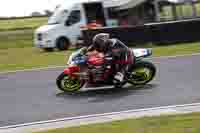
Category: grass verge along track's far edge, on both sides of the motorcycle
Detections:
[{"x1": 0, "y1": 43, "x2": 200, "y2": 71}]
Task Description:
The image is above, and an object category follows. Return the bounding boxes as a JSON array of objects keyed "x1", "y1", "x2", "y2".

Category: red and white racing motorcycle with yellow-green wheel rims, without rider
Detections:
[{"x1": 56, "y1": 48, "x2": 156, "y2": 92}]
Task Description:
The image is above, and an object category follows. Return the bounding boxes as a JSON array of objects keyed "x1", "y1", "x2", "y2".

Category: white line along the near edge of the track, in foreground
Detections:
[{"x1": 0, "y1": 103, "x2": 200, "y2": 131}]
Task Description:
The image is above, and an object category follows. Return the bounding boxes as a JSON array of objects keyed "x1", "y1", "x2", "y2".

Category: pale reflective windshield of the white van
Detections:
[{"x1": 48, "y1": 9, "x2": 68, "y2": 25}]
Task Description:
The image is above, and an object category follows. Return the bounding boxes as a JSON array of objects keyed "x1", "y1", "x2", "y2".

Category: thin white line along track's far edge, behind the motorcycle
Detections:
[{"x1": 0, "y1": 53, "x2": 200, "y2": 74}]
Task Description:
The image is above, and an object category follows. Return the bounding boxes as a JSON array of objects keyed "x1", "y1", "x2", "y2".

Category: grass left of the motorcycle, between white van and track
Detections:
[{"x1": 0, "y1": 48, "x2": 71, "y2": 71}]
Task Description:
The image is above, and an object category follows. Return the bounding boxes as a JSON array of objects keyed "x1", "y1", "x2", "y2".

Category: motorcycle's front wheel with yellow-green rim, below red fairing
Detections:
[{"x1": 56, "y1": 73, "x2": 84, "y2": 93}]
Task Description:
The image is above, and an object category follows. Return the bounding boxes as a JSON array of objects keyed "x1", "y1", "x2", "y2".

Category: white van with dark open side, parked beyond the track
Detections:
[{"x1": 34, "y1": 2, "x2": 120, "y2": 50}]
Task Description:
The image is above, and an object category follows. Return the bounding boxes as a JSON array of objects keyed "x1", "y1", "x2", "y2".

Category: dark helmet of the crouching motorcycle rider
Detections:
[{"x1": 93, "y1": 33, "x2": 110, "y2": 51}]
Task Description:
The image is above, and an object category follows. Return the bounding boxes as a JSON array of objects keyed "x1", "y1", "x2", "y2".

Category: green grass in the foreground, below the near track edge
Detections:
[{"x1": 34, "y1": 113, "x2": 200, "y2": 133}]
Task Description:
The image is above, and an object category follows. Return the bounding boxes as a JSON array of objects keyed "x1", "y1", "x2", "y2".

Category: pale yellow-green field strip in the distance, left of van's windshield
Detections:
[{"x1": 0, "y1": 17, "x2": 47, "y2": 31}]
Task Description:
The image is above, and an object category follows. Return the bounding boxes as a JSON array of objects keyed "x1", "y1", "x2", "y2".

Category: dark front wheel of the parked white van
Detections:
[{"x1": 56, "y1": 37, "x2": 70, "y2": 50}]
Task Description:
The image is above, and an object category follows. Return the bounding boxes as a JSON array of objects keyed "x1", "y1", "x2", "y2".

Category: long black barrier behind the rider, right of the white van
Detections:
[{"x1": 82, "y1": 18, "x2": 200, "y2": 45}]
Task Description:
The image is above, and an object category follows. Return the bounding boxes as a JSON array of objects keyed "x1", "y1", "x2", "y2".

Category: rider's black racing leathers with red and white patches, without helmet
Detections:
[{"x1": 88, "y1": 39, "x2": 133, "y2": 84}]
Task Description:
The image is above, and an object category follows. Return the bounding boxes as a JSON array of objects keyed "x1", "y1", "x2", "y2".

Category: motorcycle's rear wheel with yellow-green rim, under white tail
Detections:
[{"x1": 128, "y1": 61, "x2": 156, "y2": 85}]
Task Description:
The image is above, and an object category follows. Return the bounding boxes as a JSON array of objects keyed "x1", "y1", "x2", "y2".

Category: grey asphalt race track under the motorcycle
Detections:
[{"x1": 0, "y1": 56, "x2": 200, "y2": 127}]
